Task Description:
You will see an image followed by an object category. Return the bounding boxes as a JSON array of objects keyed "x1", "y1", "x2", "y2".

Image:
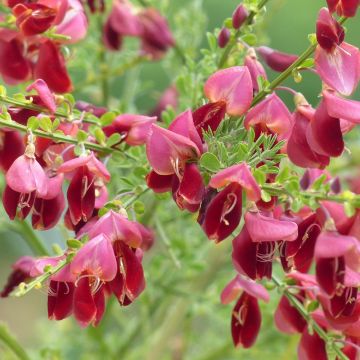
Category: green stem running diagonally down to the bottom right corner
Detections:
[{"x1": 272, "y1": 275, "x2": 348, "y2": 360}]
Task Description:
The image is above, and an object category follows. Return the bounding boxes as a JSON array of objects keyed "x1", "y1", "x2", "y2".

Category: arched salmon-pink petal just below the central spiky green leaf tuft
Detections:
[{"x1": 209, "y1": 163, "x2": 261, "y2": 201}]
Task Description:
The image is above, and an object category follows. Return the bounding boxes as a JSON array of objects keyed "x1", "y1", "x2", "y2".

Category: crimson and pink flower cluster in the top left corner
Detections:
[{"x1": 0, "y1": 0, "x2": 87, "y2": 93}]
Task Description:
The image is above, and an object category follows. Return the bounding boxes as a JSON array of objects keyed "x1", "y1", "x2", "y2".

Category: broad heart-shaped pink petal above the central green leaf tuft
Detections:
[{"x1": 204, "y1": 66, "x2": 253, "y2": 116}]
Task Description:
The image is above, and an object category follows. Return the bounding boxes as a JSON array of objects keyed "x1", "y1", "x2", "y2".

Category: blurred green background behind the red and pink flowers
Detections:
[{"x1": 0, "y1": 0, "x2": 360, "y2": 360}]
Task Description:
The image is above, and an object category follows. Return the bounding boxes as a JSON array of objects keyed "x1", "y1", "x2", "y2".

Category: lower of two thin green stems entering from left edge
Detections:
[{"x1": 0, "y1": 119, "x2": 115, "y2": 154}]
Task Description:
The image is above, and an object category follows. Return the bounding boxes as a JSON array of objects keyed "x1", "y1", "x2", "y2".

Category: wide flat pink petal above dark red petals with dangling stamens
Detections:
[{"x1": 245, "y1": 211, "x2": 298, "y2": 242}]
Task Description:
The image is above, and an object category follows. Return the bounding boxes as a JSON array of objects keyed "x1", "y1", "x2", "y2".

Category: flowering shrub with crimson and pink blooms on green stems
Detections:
[{"x1": 0, "y1": 0, "x2": 360, "y2": 360}]
